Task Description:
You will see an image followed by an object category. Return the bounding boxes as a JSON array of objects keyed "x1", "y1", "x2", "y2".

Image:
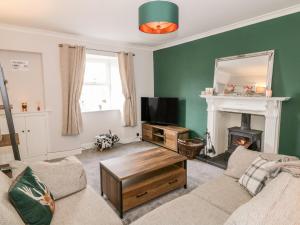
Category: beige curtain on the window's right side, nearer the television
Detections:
[{"x1": 118, "y1": 52, "x2": 137, "y2": 127}]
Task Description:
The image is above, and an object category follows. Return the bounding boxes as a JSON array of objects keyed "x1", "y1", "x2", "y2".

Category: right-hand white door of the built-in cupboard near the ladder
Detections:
[{"x1": 25, "y1": 116, "x2": 47, "y2": 158}]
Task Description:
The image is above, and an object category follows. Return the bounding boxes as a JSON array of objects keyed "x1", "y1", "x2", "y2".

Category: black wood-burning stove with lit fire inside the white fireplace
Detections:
[{"x1": 228, "y1": 113, "x2": 262, "y2": 153}]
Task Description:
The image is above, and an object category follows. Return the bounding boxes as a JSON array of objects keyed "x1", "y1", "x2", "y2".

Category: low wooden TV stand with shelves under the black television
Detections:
[{"x1": 142, "y1": 123, "x2": 189, "y2": 152}]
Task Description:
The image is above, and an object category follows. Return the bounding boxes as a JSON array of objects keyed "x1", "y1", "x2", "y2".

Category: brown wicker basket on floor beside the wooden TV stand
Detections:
[{"x1": 178, "y1": 139, "x2": 204, "y2": 159}]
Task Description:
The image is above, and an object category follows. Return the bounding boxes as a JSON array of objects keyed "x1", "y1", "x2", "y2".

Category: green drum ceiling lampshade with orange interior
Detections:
[{"x1": 139, "y1": 1, "x2": 179, "y2": 34}]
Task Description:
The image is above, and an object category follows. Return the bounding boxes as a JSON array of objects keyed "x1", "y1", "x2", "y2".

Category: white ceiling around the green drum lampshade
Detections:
[{"x1": 0, "y1": 0, "x2": 300, "y2": 46}]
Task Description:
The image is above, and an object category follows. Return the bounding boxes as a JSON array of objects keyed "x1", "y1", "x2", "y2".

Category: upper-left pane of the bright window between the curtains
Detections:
[{"x1": 84, "y1": 60, "x2": 107, "y2": 83}]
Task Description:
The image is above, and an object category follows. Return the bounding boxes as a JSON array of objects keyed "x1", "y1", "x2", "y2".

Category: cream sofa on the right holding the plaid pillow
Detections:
[{"x1": 132, "y1": 148, "x2": 300, "y2": 225}]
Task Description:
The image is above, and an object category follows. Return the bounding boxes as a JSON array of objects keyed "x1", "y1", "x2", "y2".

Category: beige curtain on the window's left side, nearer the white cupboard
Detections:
[{"x1": 60, "y1": 44, "x2": 85, "y2": 136}]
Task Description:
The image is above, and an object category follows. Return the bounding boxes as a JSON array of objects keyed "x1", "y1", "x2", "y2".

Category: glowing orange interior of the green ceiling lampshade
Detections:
[{"x1": 140, "y1": 22, "x2": 178, "y2": 34}]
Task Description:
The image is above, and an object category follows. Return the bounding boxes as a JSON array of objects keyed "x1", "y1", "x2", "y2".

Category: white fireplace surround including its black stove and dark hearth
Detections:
[{"x1": 197, "y1": 95, "x2": 290, "y2": 169}]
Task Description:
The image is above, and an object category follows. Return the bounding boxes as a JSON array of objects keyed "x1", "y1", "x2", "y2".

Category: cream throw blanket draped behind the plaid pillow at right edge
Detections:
[{"x1": 267, "y1": 160, "x2": 300, "y2": 177}]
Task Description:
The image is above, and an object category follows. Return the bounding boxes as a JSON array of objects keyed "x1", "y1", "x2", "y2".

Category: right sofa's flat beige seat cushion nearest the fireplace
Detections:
[{"x1": 190, "y1": 175, "x2": 252, "y2": 214}]
